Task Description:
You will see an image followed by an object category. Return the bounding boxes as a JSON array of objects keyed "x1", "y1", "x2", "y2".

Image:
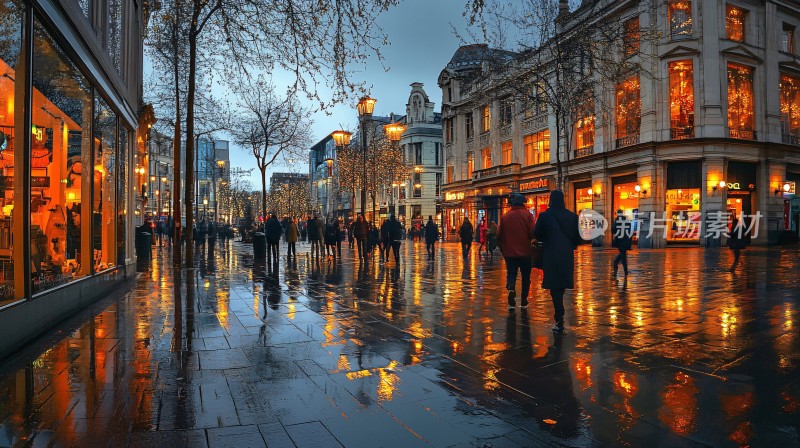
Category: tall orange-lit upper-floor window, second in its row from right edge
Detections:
[{"x1": 728, "y1": 63, "x2": 756, "y2": 140}]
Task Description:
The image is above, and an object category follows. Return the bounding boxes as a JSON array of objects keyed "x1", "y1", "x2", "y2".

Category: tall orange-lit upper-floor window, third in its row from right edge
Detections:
[{"x1": 669, "y1": 61, "x2": 694, "y2": 140}]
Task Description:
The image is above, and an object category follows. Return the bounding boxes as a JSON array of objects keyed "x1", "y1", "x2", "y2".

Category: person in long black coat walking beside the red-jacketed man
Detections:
[{"x1": 534, "y1": 190, "x2": 581, "y2": 333}]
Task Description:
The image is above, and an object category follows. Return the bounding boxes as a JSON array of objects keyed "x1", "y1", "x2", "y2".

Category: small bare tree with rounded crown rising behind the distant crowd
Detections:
[{"x1": 235, "y1": 77, "x2": 311, "y2": 222}]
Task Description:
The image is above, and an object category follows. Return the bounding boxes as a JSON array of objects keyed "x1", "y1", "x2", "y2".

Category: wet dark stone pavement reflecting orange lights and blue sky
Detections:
[{"x1": 0, "y1": 242, "x2": 800, "y2": 448}]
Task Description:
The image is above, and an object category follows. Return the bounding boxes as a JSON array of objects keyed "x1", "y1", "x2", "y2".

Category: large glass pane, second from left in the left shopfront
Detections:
[{"x1": 30, "y1": 17, "x2": 92, "y2": 293}]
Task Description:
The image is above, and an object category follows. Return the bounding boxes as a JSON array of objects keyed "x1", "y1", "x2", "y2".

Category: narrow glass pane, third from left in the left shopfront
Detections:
[{"x1": 92, "y1": 96, "x2": 117, "y2": 272}]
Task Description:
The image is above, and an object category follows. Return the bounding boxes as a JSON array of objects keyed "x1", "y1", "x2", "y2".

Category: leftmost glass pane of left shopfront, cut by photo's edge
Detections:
[{"x1": 0, "y1": 0, "x2": 26, "y2": 306}]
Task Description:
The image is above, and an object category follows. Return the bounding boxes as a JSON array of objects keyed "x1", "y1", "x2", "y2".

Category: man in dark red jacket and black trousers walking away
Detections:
[{"x1": 497, "y1": 194, "x2": 534, "y2": 308}]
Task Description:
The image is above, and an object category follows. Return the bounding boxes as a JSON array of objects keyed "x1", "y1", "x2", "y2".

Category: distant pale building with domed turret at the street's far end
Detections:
[{"x1": 396, "y1": 82, "x2": 444, "y2": 231}]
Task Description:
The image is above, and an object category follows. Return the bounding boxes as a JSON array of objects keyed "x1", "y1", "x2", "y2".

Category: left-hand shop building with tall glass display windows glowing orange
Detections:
[{"x1": 0, "y1": 0, "x2": 148, "y2": 355}]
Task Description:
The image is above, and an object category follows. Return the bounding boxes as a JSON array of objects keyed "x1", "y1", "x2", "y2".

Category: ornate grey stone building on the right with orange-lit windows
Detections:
[{"x1": 439, "y1": 0, "x2": 800, "y2": 247}]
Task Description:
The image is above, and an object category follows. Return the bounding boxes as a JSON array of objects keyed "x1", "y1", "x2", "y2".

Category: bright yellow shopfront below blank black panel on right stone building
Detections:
[{"x1": 665, "y1": 160, "x2": 703, "y2": 243}]
